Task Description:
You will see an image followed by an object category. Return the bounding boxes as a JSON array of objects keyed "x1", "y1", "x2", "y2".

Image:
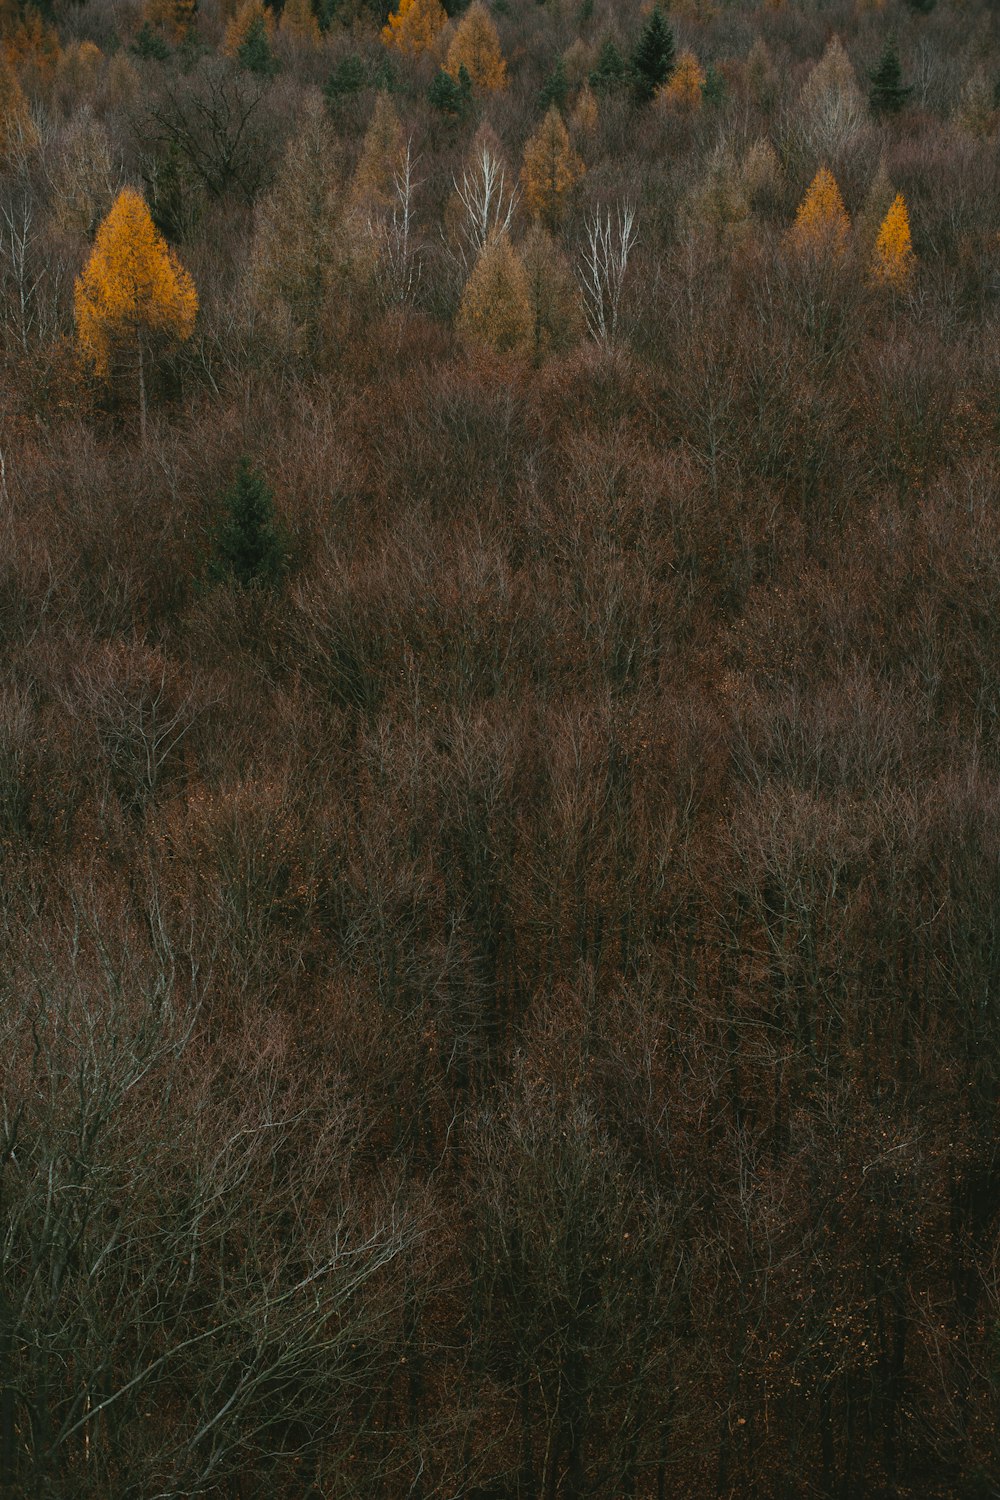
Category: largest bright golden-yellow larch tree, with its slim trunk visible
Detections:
[{"x1": 73, "y1": 188, "x2": 198, "y2": 437}]
